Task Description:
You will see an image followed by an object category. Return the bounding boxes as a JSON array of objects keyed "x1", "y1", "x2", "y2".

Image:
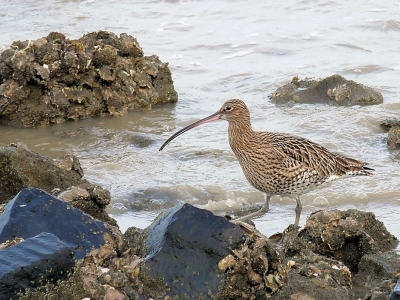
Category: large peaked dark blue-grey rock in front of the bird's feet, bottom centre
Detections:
[{"x1": 140, "y1": 204, "x2": 246, "y2": 299}]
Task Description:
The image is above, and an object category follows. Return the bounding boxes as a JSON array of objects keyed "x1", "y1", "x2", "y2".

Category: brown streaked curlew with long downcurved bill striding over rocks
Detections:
[{"x1": 160, "y1": 99, "x2": 373, "y2": 226}]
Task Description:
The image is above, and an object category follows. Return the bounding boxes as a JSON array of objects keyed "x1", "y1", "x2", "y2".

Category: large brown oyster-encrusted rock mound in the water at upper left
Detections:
[{"x1": 0, "y1": 31, "x2": 178, "y2": 127}]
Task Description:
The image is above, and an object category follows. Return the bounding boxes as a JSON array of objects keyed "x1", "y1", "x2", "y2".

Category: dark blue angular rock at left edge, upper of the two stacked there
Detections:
[{"x1": 0, "y1": 188, "x2": 107, "y2": 259}]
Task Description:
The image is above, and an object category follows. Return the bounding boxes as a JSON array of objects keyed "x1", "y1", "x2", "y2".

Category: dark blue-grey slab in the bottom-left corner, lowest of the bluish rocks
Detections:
[{"x1": 0, "y1": 232, "x2": 75, "y2": 299}]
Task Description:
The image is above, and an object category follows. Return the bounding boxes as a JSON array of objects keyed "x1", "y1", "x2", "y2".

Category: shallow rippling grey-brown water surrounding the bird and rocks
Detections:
[{"x1": 0, "y1": 0, "x2": 400, "y2": 248}]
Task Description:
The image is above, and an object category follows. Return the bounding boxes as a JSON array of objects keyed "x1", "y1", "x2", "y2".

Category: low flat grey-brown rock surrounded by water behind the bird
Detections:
[{"x1": 270, "y1": 75, "x2": 383, "y2": 106}]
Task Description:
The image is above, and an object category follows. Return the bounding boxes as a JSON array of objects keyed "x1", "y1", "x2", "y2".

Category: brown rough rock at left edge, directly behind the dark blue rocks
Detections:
[{"x1": 0, "y1": 144, "x2": 117, "y2": 225}]
